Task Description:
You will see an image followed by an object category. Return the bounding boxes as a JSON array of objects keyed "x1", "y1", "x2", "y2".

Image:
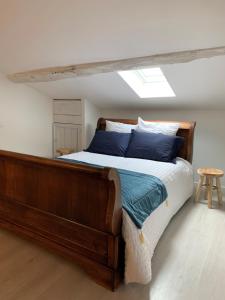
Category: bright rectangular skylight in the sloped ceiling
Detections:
[{"x1": 118, "y1": 68, "x2": 176, "y2": 98}]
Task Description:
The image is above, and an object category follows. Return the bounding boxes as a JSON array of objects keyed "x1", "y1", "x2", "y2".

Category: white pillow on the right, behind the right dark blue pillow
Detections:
[{"x1": 136, "y1": 117, "x2": 180, "y2": 135}]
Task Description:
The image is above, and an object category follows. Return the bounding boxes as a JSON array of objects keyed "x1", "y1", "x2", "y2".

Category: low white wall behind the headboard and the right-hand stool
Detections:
[{"x1": 101, "y1": 110, "x2": 225, "y2": 185}]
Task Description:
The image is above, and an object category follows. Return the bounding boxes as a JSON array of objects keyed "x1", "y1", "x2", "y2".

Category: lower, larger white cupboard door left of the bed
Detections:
[{"x1": 53, "y1": 123, "x2": 82, "y2": 157}]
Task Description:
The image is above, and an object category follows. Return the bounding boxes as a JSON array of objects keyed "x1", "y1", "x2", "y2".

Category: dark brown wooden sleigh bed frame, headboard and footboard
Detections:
[{"x1": 0, "y1": 118, "x2": 195, "y2": 290}]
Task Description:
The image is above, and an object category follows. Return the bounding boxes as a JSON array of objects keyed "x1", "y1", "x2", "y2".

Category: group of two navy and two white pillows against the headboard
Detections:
[{"x1": 86, "y1": 117, "x2": 184, "y2": 163}]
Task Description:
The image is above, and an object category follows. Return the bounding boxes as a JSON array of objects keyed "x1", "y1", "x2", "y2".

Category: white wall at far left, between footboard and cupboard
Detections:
[{"x1": 0, "y1": 74, "x2": 52, "y2": 157}]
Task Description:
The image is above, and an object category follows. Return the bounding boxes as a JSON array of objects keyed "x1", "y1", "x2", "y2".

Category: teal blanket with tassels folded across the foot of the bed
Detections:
[{"x1": 58, "y1": 158, "x2": 167, "y2": 228}]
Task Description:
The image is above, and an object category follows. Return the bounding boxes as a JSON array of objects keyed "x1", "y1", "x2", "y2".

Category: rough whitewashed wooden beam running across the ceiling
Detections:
[{"x1": 7, "y1": 46, "x2": 225, "y2": 83}]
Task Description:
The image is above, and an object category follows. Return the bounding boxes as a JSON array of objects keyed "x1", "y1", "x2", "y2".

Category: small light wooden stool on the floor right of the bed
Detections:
[{"x1": 195, "y1": 168, "x2": 224, "y2": 208}]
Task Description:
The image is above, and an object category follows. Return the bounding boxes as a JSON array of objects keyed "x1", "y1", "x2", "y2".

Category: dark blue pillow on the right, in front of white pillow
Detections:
[{"x1": 126, "y1": 130, "x2": 184, "y2": 162}]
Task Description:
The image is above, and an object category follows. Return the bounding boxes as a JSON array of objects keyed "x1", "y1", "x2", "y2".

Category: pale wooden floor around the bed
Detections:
[{"x1": 0, "y1": 198, "x2": 225, "y2": 300}]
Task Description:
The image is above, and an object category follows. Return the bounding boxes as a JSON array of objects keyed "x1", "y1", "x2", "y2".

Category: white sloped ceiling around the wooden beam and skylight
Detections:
[{"x1": 0, "y1": 0, "x2": 225, "y2": 109}]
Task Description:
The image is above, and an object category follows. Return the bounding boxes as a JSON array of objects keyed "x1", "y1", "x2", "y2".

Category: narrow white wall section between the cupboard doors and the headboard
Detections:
[{"x1": 83, "y1": 100, "x2": 101, "y2": 148}]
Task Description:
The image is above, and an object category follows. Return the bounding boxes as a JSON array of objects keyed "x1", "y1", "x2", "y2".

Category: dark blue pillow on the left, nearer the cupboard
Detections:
[{"x1": 86, "y1": 130, "x2": 131, "y2": 156}]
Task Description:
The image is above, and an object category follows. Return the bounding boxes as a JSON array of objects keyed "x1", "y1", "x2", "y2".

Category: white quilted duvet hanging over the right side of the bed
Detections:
[{"x1": 63, "y1": 152, "x2": 193, "y2": 284}]
